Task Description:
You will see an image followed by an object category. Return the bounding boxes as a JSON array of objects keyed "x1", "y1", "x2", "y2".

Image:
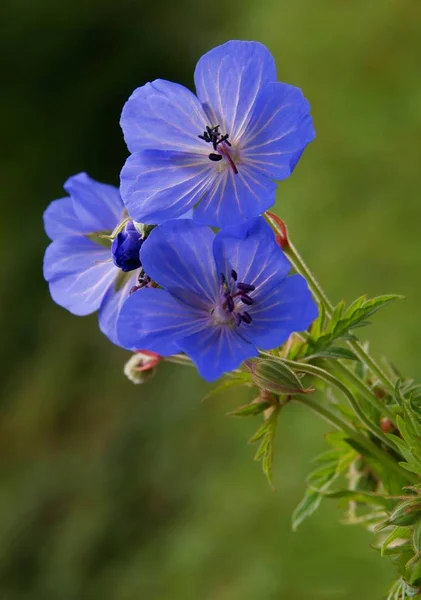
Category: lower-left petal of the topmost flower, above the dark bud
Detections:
[{"x1": 121, "y1": 150, "x2": 215, "y2": 224}]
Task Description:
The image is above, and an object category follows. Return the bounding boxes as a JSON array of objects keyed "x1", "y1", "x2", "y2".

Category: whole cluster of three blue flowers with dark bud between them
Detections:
[{"x1": 44, "y1": 41, "x2": 317, "y2": 380}]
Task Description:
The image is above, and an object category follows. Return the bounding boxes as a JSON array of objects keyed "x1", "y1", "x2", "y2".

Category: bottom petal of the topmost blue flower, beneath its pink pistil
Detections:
[{"x1": 193, "y1": 164, "x2": 276, "y2": 227}]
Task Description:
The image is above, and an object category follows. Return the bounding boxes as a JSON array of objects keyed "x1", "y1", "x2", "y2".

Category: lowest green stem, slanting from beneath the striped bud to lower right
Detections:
[{"x1": 293, "y1": 395, "x2": 418, "y2": 483}]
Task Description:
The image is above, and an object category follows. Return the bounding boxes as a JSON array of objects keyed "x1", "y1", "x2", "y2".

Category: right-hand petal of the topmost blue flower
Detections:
[{"x1": 239, "y1": 83, "x2": 315, "y2": 179}]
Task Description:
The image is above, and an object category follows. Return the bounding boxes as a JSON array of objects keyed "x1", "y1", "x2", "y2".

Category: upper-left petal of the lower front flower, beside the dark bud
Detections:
[{"x1": 140, "y1": 219, "x2": 220, "y2": 308}]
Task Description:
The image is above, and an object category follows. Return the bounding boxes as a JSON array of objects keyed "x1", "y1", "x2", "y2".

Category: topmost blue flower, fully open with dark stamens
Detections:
[{"x1": 121, "y1": 41, "x2": 315, "y2": 227}]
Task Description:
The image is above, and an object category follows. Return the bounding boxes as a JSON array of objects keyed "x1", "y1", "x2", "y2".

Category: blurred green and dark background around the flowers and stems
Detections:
[{"x1": 0, "y1": 0, "x2": 421, "y2": 600}]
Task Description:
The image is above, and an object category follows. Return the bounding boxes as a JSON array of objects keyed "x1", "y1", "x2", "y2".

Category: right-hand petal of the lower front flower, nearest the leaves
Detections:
[{"x1": 244, "y1": 275, "x2": 318, "y2": 350}]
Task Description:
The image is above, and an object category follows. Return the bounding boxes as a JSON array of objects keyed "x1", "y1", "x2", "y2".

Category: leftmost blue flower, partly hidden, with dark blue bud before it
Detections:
[{"x1": 44, "y1": 173, "x2": 142, "y2": 344}]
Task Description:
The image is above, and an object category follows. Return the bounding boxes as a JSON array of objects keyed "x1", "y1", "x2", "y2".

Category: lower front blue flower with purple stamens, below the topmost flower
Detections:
[{"x1": 117, "y1": 217, "x2": 317, "y2": 381}]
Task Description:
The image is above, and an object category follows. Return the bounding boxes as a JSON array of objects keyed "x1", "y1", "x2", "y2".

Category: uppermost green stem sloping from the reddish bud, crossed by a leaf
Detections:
[{"x1": 284, "y1": 241, "x2": 395, "y2": 393}]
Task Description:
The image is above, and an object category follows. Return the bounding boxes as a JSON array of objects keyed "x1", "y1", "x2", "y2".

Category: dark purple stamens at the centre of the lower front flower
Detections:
[{"x1": 212, "y1": 269, "x2": 256, "y2": 327}]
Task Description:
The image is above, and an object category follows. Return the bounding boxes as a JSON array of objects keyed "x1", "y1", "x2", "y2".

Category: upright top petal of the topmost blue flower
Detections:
[{"x1": 194, "y1": 41, "x2": 276, "y2": 140}]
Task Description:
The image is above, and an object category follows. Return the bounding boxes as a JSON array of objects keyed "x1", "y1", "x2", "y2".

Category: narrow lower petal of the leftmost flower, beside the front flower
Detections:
[{"x1": 98, "y1": 270, "x2": 139, "y2": 350}]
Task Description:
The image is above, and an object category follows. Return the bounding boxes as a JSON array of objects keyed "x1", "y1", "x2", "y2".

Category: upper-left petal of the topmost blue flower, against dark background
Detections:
[{"x1": 120, "y1": 79, "x2": 208, "y2": 153}]
